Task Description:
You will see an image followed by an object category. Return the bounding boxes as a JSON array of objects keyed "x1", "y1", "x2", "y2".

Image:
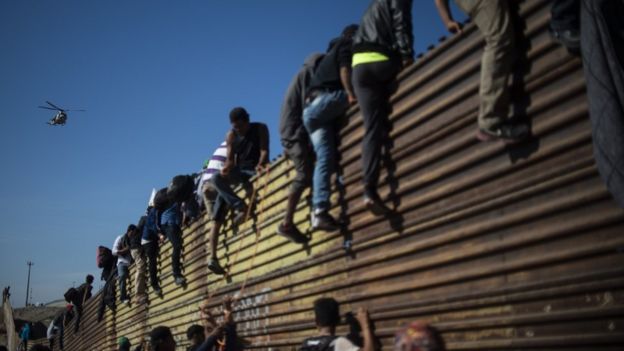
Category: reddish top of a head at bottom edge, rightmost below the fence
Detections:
[{"x1": 394, "y1": 321, "x2": 446, "y2": 351}]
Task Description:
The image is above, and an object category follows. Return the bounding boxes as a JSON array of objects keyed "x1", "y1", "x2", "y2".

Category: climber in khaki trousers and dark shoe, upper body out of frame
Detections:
[{"x1": 435, "y1": 0, "x2": 529, "y2": 143}]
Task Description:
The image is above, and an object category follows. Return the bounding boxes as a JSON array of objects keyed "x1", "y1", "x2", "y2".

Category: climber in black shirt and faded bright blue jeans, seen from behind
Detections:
[{"x1": 303, "y1": 24, "x2": 357, "y2": 231}]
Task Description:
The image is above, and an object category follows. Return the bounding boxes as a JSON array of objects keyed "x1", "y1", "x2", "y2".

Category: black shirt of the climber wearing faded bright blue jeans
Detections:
[{"x1": 310, "y1": 37, "x2": 353, "y2": 90}]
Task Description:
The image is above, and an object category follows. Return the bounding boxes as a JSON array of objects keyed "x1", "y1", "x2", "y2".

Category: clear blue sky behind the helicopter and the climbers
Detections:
[{"x1": 0, "y1": 0, "x2": 463, "y2": 306}]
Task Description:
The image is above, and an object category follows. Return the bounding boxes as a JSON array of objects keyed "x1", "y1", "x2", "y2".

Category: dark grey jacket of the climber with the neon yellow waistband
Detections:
[{"x1": 353, "y1": 0, "x2": 414, "y2": 59}]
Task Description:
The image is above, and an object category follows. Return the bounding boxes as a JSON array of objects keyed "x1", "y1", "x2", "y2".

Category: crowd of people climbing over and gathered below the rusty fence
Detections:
[{"x1": 7, "y1": 0, "x2": 620, "y2": 351}]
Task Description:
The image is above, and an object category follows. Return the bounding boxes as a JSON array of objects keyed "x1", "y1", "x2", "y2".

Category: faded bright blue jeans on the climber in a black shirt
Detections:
[{"x1": 303, "y1": 90, "x2": 349, "y2": 211}]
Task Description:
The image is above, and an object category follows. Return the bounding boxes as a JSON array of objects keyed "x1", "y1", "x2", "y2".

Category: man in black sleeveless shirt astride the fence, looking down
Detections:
[{"x1": 208, "y1": 107, "x2": 269, "y2": 275}]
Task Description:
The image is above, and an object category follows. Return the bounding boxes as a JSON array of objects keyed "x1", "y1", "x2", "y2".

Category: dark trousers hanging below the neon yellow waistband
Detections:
[{"x1": 353, "y1": 60, "x2": 399, "y2": 196}]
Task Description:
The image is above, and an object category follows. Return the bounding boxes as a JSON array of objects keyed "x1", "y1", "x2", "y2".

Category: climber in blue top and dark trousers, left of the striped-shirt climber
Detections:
[{"x1": 159, "y1": 201, "x2": 186, "y2": 286}]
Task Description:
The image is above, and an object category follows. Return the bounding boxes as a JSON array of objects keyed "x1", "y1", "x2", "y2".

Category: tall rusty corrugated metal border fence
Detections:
[{"x1": 58, "y1": 0, "x2": 624, "y2": 351}]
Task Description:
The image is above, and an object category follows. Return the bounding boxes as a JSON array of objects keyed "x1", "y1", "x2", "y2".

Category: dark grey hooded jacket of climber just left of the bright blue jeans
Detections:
[{"x1": 280, "y1": 53, "x2": 324, "y2": 147}]
